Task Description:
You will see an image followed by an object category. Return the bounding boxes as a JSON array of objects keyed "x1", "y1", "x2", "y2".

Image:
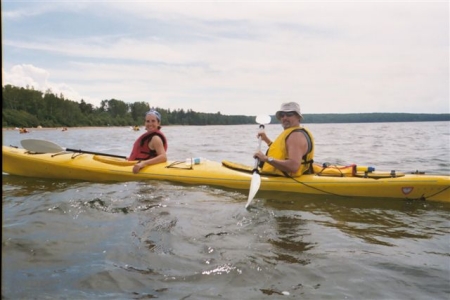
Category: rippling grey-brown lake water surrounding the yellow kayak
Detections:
[{"x1": 2, "y1": 122, "x2": 450, "y2": 300}]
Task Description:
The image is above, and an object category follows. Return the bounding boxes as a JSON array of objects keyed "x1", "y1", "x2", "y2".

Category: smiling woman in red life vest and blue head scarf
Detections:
[{"x1": 128, "y1": 110, "x2": 167, "y2": 174}]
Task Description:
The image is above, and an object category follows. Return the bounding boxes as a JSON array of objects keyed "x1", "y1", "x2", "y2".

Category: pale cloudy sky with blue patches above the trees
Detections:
[{"x1": 1, "y1": 0, "x2": 450, "y2": 116}]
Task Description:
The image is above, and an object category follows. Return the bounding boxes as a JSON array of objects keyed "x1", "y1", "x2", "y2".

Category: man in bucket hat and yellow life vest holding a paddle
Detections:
[{"x1": 254, "y1": 102, "x2": 314, "y2": 177}]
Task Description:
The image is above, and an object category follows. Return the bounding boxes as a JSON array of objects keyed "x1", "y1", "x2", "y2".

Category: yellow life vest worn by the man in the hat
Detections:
[{"x1": 261, "y1": 126, "x2": 314, "y2": 177}]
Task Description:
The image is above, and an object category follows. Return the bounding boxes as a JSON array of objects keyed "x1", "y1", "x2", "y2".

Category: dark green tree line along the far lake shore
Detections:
[{"x1": 2, "y1": 85, "x2": 450, "y2": 127}]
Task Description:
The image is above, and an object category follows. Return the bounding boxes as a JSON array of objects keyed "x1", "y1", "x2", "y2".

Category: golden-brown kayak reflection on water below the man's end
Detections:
[{"x1": 260, "y1": 193, "x2": 450, "y2": 241}]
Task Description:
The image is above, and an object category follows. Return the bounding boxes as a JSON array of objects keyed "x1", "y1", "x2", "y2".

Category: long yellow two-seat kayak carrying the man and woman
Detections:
[{"x1": 2, "y1": 146, "x2": 450, "y2": 202}]
